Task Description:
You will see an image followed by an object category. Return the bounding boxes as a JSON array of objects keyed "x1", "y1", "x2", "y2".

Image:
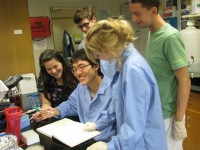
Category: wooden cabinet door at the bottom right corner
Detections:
[{"x1": 184, "y1": 109, "x2": 200, "y2": 150}]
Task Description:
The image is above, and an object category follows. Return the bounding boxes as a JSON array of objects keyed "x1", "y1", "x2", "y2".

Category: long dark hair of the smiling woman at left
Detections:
[{"x1": 39, "y1": 49, "x2": 78, "y2": 95}]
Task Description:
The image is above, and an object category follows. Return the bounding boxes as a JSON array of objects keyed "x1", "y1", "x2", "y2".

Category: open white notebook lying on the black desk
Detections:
[{"x1": 37, "y1": 118, "x2": 101, "y2": 147}]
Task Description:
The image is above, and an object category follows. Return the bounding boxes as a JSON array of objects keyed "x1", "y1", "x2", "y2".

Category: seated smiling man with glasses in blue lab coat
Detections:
[{"x1": 32, "y1": 49, "x2": 116, "y2": 141}]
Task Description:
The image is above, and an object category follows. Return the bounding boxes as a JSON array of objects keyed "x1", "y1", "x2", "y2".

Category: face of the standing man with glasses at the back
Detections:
[{"x1": 77, "y1": 17, "x2": 96, "y2": 33}]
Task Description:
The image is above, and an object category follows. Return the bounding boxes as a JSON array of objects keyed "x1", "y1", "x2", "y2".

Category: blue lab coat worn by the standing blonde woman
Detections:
[{"x1": 96, "y1": 44, "x2": 167, "y2": 150}]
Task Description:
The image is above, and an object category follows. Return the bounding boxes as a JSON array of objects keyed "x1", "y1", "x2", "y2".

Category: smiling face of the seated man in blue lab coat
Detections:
[{"x1": 72, "y1": 60, "x2": 99, "y2": 85}]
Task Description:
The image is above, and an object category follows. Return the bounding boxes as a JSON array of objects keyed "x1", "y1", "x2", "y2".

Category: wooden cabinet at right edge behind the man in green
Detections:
[{"x1": 183, "y1": 92, "x2": 200, "y2": 150}]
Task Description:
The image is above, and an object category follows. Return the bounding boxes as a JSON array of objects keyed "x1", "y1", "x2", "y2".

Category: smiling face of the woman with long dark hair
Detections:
[{"x1": 44, "y1": 58, "x2": 63, "y2": 79}]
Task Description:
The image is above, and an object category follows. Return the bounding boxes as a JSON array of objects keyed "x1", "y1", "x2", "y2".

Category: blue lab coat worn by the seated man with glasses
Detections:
[{"x1": 56, "y1": 76, "x2": 116, "y2": 141}]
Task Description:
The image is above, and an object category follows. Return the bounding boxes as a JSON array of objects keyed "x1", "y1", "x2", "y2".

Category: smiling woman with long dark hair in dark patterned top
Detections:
[{"x1": 37, "y1": 49, "x2": 78, "y2": 109}]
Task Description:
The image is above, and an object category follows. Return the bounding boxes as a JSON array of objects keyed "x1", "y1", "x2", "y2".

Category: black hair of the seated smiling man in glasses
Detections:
[{"x1": 71, "y1": 49, "x2": 103, "y2": 76}]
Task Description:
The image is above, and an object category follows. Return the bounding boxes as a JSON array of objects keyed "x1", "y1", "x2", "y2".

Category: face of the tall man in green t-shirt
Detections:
[{"x1": 130, "y1": 3, "x2": 155, "y2": 28}]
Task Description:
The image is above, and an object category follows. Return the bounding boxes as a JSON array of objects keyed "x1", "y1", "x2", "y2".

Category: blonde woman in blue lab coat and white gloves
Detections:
[{"x1": 84, "y1": 18, "x2": 167, "y2": 150}]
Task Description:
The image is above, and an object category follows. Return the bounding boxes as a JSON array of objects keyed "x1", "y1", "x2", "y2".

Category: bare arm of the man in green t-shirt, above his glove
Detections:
[{"x1": 175, "y1": 67, "x2": 191, "y2": 121}]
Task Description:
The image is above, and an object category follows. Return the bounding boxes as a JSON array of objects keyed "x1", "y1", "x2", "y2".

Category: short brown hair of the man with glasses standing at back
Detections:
[{"x1": 74, "y1": 6, "x2": 94, "y2": 24}]
